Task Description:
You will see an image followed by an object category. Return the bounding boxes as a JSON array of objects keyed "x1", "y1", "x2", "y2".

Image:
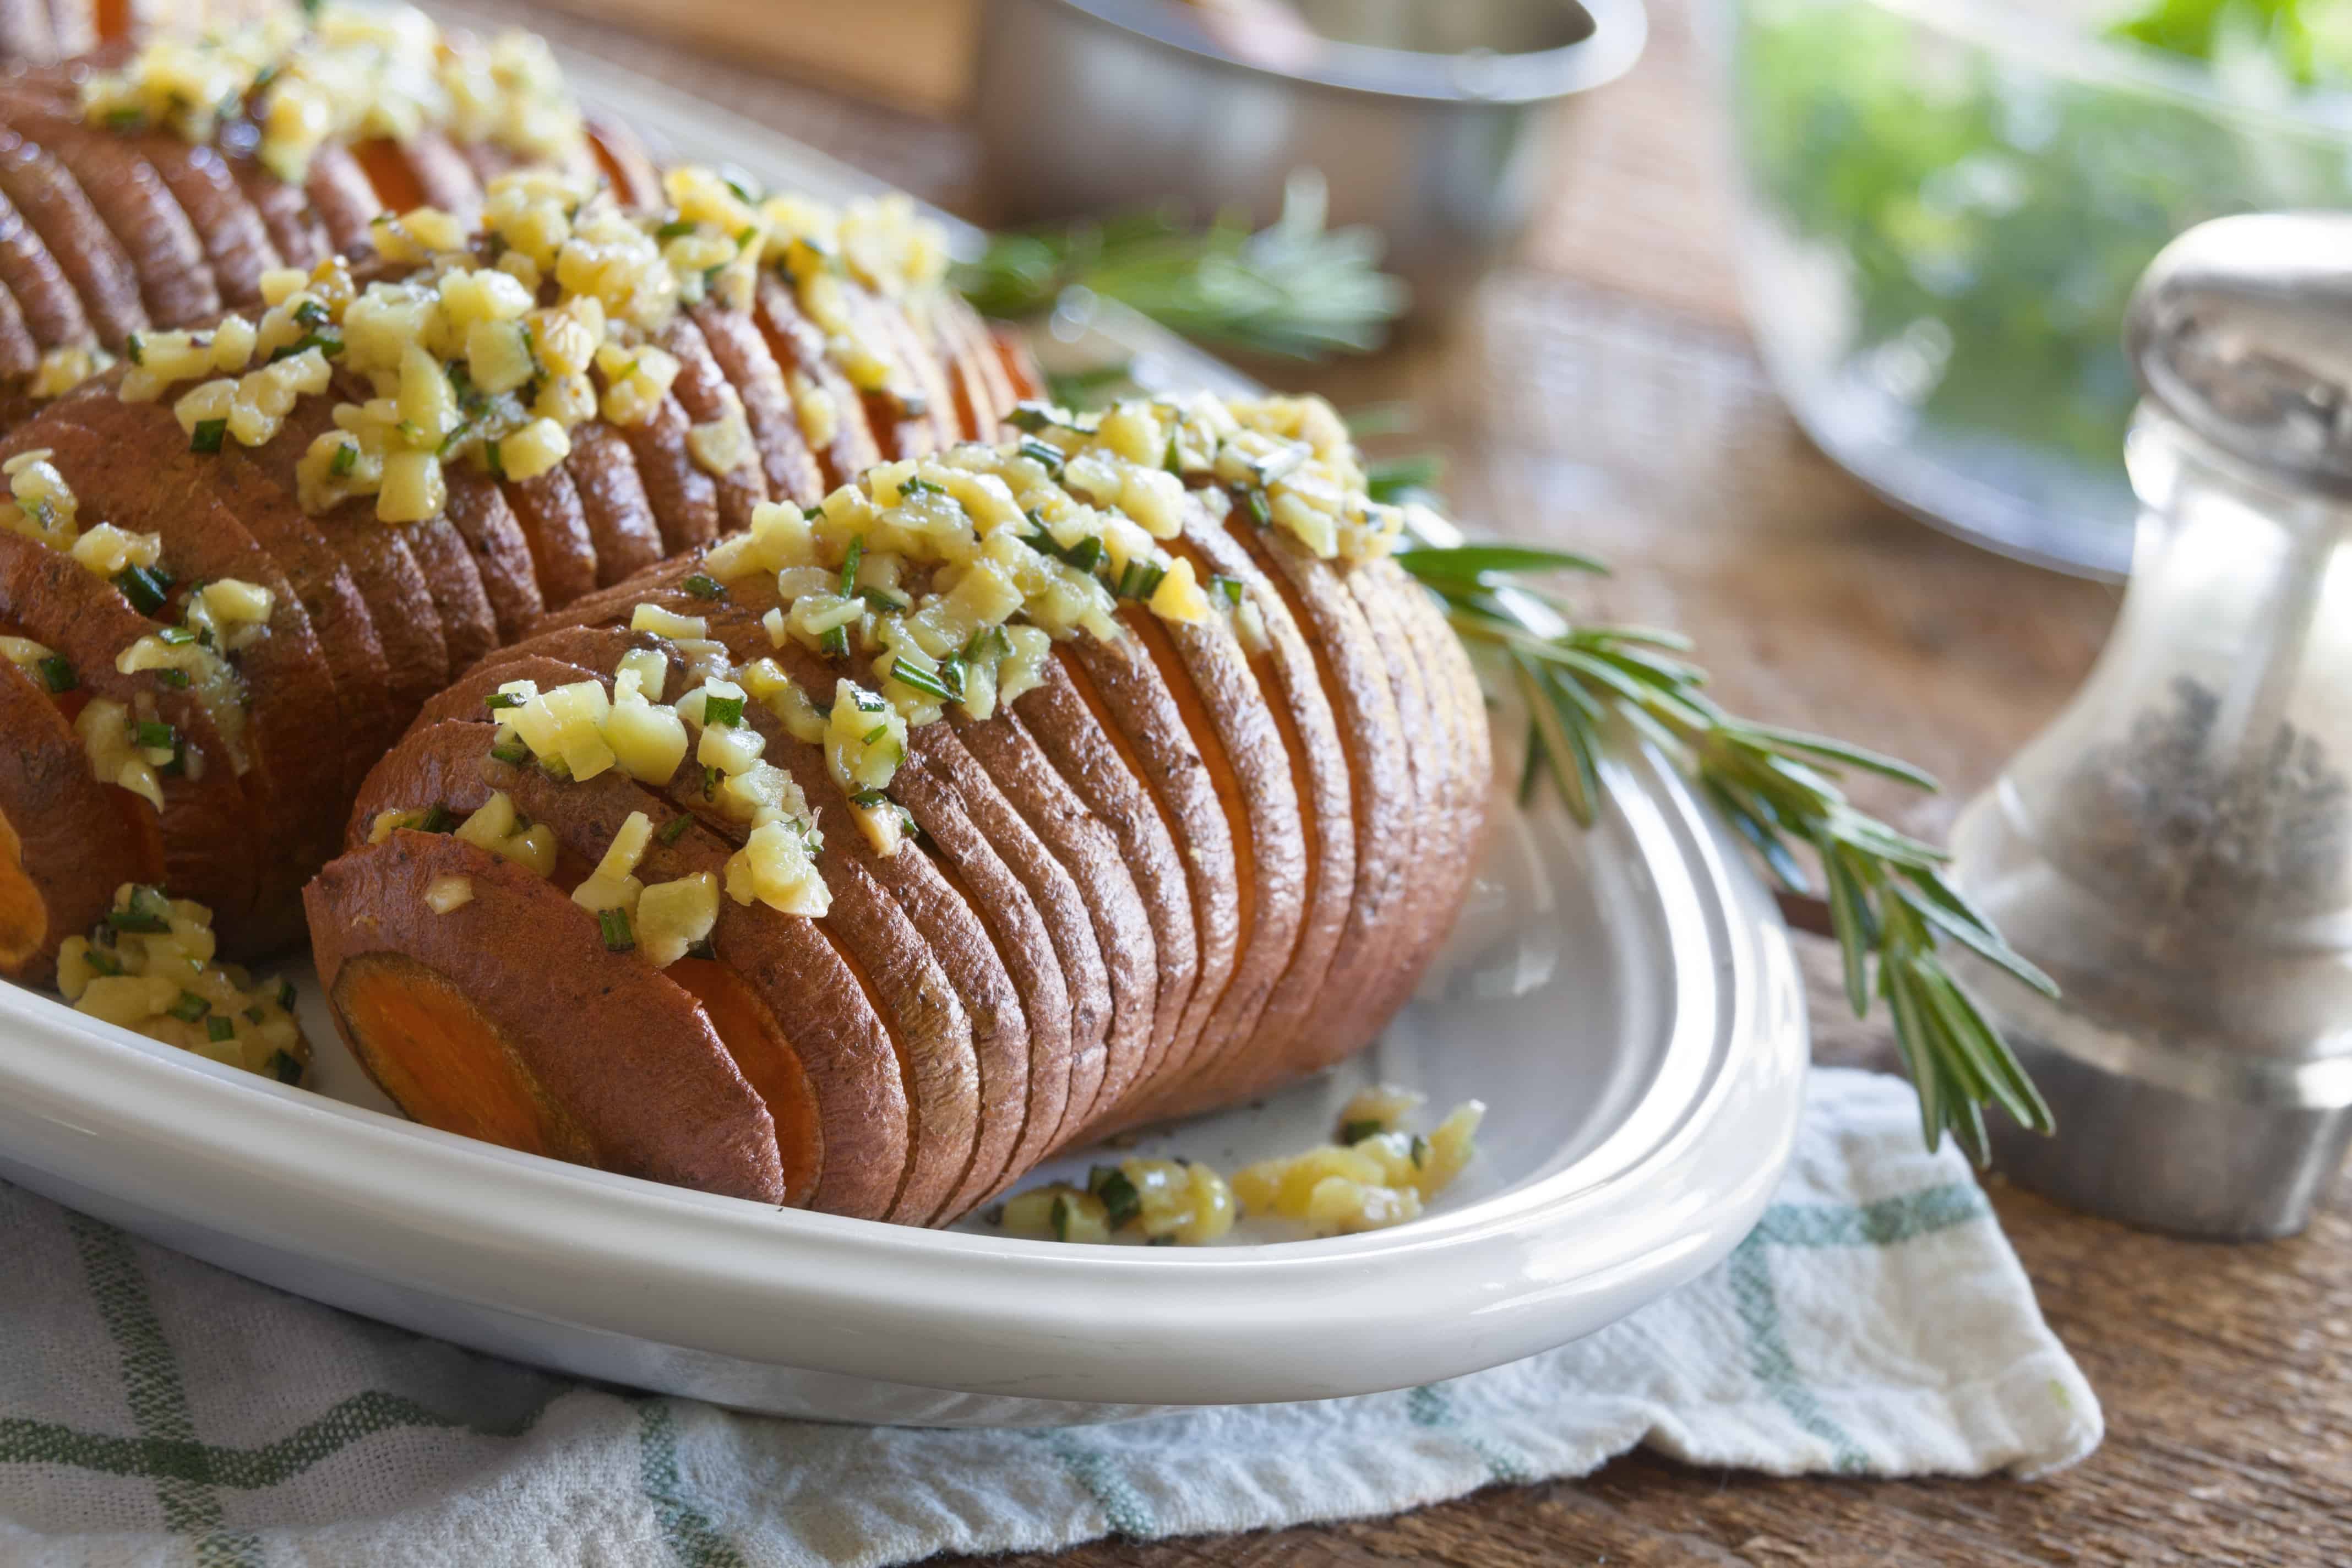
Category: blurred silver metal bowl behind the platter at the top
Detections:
[{"x1": 978, "y1": 0, "x2": 1649, "y2": 308}]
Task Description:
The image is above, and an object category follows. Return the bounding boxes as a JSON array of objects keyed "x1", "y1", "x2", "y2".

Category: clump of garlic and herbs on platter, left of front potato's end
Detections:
[{"x1": 57, "y1": 884, "x2": 311, "y2": 1084}]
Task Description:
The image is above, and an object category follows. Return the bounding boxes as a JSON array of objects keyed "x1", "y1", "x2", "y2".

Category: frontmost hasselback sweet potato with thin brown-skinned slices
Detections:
[{"x1": 308, "y1": 395, "x2": 1489, "y2": 1222}]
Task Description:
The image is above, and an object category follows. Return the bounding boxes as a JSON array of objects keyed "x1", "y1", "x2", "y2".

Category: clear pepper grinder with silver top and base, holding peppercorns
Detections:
[{"x1": 1952, "y1": 214, "x2": 2352, "y2": 1237}]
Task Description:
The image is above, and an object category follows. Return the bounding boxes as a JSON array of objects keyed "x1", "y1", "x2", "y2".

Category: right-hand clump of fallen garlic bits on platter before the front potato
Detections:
[{"x1": 1233, "y1": 1091, "x2": 1487, "y2": 1237}]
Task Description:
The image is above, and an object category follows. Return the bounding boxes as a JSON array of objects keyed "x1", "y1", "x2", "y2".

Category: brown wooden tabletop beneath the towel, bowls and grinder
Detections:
[{"x1": 505, "y1": 0, "x2": 2352, "y2": 1568}]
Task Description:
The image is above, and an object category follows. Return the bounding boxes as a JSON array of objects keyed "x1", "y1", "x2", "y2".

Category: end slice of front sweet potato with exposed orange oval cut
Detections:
[{"x1": 306, "y1": 832, "x2": 788, "y2": 1204}]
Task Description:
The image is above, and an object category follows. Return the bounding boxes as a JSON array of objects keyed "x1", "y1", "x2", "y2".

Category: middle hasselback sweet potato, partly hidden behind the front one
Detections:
[{"x1": 0, "y1": 181, "x2": 1030, "y2": 994}]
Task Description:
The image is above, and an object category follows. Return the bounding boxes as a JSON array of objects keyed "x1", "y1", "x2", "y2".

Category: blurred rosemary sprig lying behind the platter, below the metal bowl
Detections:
[{"x1": 955, "y1": 172, "x2": 1407, "y2": 360}]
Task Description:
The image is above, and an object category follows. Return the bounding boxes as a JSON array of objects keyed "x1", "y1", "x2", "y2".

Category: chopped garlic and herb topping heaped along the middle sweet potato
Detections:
[{"x1": 120, "y1": 167, "x2": 945, "y2": 522}]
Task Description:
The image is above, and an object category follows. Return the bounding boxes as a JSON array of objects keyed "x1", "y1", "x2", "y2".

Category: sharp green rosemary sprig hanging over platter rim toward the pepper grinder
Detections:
[{"x1": 1397, "y1": 546, "x2": 2058, "y2": 1164}]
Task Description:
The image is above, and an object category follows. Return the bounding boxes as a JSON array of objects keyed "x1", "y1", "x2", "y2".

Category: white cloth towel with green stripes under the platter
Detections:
[{"x1": 0, "y1": 1070, "x2": 2100, "y2": 1568}]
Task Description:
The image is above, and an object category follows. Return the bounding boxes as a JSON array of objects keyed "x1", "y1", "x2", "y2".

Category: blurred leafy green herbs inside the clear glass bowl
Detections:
[{"x1": 1736, "y1": 0, "x2": 2352, "y2": 491}]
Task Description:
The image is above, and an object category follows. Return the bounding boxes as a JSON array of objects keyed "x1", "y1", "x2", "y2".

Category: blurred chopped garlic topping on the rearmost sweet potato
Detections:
[{"x1": 83, "y1": 5, "x2": 583, "y2": 183}]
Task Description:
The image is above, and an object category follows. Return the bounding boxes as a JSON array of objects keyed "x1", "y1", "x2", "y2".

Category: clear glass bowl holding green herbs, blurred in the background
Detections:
[{"x1": 1717, "y1": 0, "x2": 2352, "y2": 576}]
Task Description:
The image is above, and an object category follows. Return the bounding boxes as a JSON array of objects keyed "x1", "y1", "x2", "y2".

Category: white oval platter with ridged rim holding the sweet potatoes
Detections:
[{"x1": 0, "y1": 52, "x2": 1806, "y2": 1425}]
